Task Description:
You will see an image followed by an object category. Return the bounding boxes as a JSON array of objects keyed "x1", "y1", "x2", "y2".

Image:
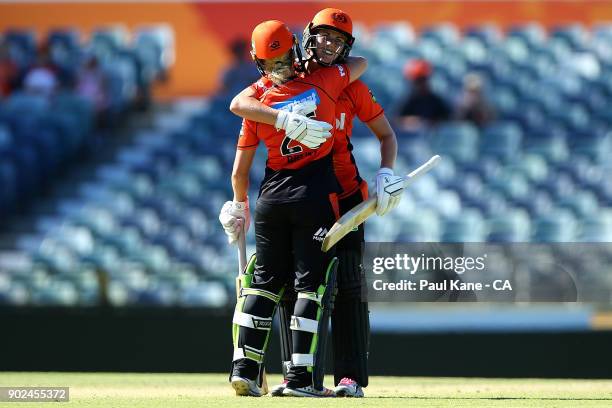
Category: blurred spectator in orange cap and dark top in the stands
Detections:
[{"x1": 398, "y1": 60, "x2": 451, "y2": 131}]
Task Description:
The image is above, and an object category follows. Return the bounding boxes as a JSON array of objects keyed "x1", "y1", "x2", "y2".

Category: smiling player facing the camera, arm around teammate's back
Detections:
[{"x1": 227, "y1": 8, "x2": 403, "y2": 397}]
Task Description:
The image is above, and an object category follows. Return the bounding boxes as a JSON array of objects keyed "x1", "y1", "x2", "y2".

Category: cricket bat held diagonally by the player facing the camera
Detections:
[{"x1": 321, "y1": 155, "x2": 440, "y2": 252}]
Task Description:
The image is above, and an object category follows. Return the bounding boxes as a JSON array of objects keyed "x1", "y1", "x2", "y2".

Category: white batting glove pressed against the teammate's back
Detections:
[{"x1": 274, "y1": 105, "x2": 332, "y2": 149}]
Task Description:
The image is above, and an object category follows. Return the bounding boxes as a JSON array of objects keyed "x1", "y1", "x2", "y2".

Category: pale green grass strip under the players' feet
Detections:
[{"x1": 0, "y1": 373, "x2": 612, "y2": 408}]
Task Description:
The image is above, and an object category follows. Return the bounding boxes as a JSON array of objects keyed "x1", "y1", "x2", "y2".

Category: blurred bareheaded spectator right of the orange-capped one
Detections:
[{"x1": 455, "y1": 73, "x2": 495, "y2": 127}]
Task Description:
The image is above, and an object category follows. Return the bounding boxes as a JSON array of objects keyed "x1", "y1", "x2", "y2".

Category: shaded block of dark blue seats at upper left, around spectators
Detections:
[{"x1": 0, "y1": 26, "x2": 173, "y2": 216}]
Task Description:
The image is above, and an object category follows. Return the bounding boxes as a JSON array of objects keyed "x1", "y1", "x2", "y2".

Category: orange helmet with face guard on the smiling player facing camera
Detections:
[{"x1": 302, "y1": 8, "x2": 355, "y2": 65}]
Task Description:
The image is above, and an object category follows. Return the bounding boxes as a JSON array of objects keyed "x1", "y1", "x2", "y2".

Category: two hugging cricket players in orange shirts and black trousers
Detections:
[{"x1": 219, "y1": 8, "x2": 403, "y2": 397}]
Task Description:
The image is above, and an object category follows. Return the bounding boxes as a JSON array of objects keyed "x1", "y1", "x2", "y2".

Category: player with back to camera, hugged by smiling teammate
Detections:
[{"x1": 219, "y1": 20, "x2": 367, "y2": 397}]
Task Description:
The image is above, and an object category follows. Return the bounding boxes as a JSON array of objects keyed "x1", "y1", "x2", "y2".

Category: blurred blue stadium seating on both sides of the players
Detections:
[{"x1": 0, "y1": 23, "x2": 612, "y2": 306}]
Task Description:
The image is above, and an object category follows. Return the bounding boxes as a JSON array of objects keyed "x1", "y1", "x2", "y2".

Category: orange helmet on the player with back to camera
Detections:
[{"x1": 251, "y1": 20, "x2": 302, "y2": 76}]
